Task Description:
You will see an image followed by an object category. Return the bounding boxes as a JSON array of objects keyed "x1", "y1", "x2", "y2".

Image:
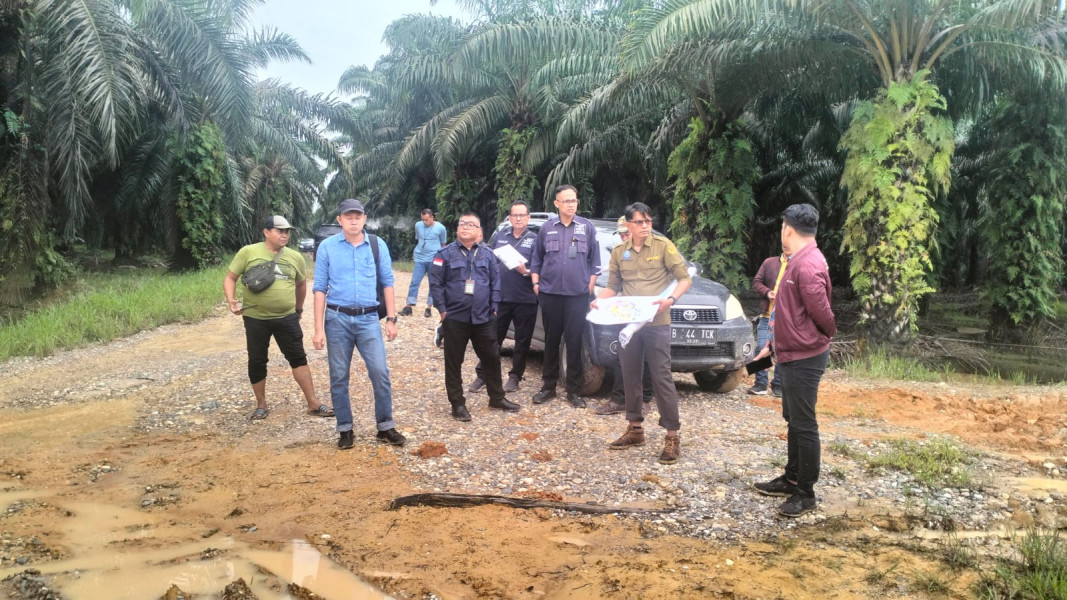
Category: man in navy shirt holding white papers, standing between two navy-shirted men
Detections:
[{"x1": 467, "y1": 200, "x2": 537, "y2": 393}]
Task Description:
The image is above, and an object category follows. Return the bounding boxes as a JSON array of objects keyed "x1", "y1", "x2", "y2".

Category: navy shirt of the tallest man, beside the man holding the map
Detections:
[{"x1": 530, "y1": 216, "x2": 600, "y2": 296}]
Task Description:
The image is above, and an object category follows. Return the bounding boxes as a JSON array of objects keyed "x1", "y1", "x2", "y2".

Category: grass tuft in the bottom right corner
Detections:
[{"x1": 976, "y1": 531, "x2": 1067, "y2": 600}]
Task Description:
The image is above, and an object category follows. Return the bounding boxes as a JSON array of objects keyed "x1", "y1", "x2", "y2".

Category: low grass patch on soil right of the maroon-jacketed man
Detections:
[{"x1": 867, "y1": 438, "x2": 973, "y2": 488}]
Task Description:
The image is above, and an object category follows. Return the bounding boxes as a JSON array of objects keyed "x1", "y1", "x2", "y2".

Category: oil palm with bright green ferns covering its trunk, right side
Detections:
[{"x1": 623, "y1": 0, "x2": 1067, "y2": 343}]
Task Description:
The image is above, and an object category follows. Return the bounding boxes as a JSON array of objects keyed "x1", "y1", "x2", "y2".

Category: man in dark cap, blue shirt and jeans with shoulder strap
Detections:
[{"x1": 312, "y1": 200, "x2": 404, "y2": 449}]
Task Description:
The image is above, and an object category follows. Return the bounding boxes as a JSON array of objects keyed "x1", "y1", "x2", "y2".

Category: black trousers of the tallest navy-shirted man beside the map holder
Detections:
[{"x1": 538, "y1": 294, "x2": 589, "y2": 394}]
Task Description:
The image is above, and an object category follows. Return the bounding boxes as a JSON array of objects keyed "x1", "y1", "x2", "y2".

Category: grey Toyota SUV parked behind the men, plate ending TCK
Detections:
[{"x1": 497, "y1": 212, "x2": 755, "y2": 395}]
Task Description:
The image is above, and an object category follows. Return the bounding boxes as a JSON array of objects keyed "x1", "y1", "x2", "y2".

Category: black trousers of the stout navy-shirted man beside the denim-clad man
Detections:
[{"x1": 441, "y1": 318, "x2": 505, "y2": 406}]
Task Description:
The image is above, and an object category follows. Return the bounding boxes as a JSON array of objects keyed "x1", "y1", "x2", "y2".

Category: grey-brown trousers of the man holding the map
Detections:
[{"x1": 619, "y1": 325, "x2": 681, "y2": 431}]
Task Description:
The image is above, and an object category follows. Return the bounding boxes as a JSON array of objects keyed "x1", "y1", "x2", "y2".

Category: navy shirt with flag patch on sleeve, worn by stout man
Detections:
[{"x1": 430, "y1": 240, "x2": 500, "y2": 325}]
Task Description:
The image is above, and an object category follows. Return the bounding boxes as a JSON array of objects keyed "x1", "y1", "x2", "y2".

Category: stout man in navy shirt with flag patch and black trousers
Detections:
[{"x1": 430, "y1": 212, "x2": 520, "y2": 421}]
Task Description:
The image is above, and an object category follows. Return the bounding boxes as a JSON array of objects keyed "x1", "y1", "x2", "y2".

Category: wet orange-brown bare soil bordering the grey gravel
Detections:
[{"x1": 0, "y1": 272, "x2": 1067, "y2": 599}]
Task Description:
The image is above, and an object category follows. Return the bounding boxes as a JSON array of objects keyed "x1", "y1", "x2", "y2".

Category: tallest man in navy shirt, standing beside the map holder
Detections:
[{"x1": 530, "y1": 186, "x2": 600, "y2": 408}]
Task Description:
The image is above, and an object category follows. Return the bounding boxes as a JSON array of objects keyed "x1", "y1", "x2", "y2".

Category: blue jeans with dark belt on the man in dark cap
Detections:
[{"x1": 324, "y1": 309, "x2": 396, "y2": 431}]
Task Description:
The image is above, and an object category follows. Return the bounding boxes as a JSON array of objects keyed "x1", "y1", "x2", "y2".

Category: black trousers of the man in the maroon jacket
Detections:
[{"x1": 775, "y1": 350, "x2": 830, "y2": 495}]
